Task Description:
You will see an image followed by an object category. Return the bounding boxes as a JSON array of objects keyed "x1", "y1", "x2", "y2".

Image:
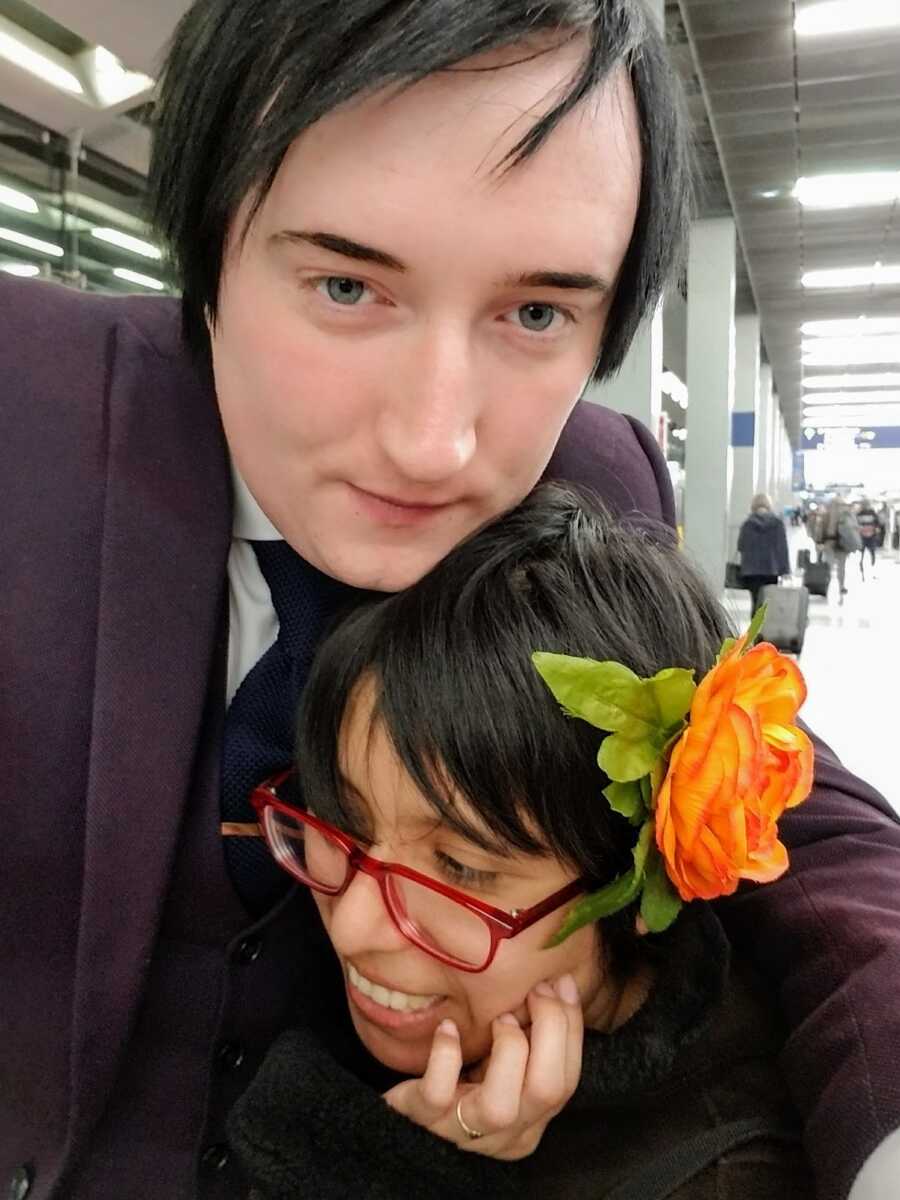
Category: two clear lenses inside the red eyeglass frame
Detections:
[{"x1": 265, "y1": 808, "x2": 491, "y2": 967}]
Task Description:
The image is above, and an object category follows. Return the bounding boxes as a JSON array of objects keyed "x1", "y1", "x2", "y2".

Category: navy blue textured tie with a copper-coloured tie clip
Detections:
[{"x1": 222, "y1": 541, "x2": 360, "y2": 917}]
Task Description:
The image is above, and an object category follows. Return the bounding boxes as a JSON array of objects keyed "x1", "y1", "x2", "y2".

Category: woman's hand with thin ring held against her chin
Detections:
[{"x1": 384, "y1": 976, "x2": 584, "y2": 1159}]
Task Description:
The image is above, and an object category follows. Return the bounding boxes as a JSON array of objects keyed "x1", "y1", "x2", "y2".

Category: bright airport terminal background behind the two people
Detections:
[{"x1": 0, "y1": 0, "x2": 900, "y2": 825}]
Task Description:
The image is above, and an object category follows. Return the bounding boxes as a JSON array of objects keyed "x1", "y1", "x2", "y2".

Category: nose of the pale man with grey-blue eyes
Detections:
[{"x1": 378, "y1": 324, "x2": 481, "y2": 486}]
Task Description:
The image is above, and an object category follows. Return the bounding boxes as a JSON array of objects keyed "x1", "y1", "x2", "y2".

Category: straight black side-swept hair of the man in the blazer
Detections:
[{"x1": 149, "y1": 0, "x2": 692, "y2": 378}]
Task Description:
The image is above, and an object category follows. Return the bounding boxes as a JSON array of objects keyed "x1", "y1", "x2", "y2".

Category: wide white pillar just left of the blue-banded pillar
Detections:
[{"x1": 684, "y1": 217, "x2": 737, "y2": 593}]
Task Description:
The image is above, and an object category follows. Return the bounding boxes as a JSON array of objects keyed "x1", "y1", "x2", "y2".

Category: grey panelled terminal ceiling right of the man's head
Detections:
[{"x1": 667, "y1": 0, "x2": 900, "y2": 444}]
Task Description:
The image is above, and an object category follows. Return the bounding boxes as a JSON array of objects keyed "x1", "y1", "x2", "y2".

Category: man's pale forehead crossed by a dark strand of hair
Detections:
[{"x1": 270, "y1": 41, "x2": 640, "y2": 208}]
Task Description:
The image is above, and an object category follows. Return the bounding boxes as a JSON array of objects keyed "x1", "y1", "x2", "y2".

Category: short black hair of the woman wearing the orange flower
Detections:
[{"x1": 296, "y1": 484, "x2": 730, "y2": 969}]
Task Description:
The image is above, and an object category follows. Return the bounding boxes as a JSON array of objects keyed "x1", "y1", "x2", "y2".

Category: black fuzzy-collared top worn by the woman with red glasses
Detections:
[{"x1": 229, "y1": 905, "x2": 812, "y2": 1200}]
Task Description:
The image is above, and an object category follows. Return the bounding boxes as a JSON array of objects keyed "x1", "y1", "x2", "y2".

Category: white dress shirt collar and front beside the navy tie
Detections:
[{"x1": 226, "y1": 463, "x2": 283, "y2": 704}]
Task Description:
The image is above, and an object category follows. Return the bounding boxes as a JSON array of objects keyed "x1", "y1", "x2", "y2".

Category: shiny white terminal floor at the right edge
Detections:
[{"x1": 725, "y1": 530, "x2": 900, "y2": 811}]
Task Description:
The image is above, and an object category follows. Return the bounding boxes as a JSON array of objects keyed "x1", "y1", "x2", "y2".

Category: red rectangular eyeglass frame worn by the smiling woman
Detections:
[{"x1": 250, "y1": 768, "x2": 586, "y2": 974}]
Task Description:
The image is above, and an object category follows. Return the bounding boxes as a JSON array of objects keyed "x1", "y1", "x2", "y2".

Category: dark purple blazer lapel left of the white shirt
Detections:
[{"x1": 70, "y1": 320, "x2": 232, "y2": 1146}]
